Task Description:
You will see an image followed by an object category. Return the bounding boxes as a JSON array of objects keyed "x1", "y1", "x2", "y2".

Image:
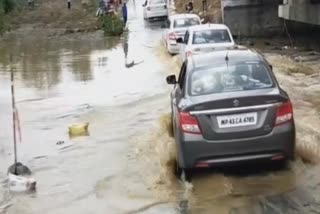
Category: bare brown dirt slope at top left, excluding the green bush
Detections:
[{"x1": 8, "y1": 0, "x2": 100, "y2": 34}]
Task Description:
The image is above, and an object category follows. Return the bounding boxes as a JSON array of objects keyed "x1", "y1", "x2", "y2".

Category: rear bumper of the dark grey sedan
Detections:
[{"x1": 178, "y1": 124, "x2": 295, "y2": 169}]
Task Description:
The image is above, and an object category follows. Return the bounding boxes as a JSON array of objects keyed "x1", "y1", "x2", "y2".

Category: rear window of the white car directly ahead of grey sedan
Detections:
[{"x1": 192, "y1": 29, "x2": 231, "y2": 45}]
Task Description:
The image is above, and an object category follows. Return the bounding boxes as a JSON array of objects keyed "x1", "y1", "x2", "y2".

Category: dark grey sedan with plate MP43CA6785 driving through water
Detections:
[{"x1": 167, "y1": 46, "x2": 295, "y2": 179}]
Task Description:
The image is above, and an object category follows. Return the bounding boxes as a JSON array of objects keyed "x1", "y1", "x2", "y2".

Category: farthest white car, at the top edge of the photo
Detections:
[{"x1": 142, "y1": 0, "x2": 169, "y2": 20}]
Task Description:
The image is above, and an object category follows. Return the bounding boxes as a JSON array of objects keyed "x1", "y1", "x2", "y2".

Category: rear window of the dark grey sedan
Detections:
[{"x1": 189, "y1": 62, "x2": 274, "y2": 96}]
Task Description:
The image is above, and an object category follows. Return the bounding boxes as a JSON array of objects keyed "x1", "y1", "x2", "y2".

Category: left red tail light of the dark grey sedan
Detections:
[{"x1": 179, "y1": 112, "x2": 201, "y2": 134}]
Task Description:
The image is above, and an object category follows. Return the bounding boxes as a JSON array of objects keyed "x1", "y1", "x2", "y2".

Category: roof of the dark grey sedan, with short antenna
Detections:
[{"x1": 189, "y1": 46, "x2": 265, "y2": 69}]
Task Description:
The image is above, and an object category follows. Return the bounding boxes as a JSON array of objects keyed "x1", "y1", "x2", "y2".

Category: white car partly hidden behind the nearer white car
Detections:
[{"x1": 161, "y1": 14, "x2": 201, "y2": 54}]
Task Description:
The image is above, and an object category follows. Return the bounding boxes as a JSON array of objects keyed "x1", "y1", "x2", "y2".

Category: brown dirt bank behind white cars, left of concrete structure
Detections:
[{"x1": 175, "y1": 0, "x2": 222, "y2": 23}]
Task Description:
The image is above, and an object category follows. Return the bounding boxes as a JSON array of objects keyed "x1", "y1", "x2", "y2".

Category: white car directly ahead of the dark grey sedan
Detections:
[{"x1": 177, "y1": 24, "x2": 235, "y2": 62}]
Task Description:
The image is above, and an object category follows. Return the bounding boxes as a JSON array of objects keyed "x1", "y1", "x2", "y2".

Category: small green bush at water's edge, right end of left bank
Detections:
[{"x1": 101, "y1": 15, "x2": 124, "y2": 36}]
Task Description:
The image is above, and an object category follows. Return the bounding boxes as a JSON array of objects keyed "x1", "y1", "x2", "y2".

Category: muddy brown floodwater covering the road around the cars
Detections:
[{"x1": 0, "y1": 1, "x2": 320, "y2": 214}]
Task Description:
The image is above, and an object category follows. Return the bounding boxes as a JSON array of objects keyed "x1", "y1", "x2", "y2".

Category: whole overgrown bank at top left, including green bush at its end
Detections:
[{"x1": 0, "y1": 0, "x2": 124, "y2": 36}]
